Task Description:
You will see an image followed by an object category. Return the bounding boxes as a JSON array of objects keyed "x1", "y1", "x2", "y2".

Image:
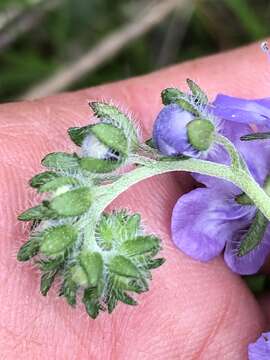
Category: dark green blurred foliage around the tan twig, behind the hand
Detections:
[{"x1": 0, "y1": 0, "x2": 270, "y2": 102}]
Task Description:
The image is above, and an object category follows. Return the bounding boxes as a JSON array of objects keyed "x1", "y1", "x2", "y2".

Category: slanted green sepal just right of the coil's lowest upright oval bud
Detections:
[{"x1": 108, "y1": 255, "x2": 141, "y2": 279}]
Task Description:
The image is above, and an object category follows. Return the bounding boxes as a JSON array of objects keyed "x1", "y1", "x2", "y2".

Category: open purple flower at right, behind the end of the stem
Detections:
[{"x1": 171, "y1": 96, "x2": 270, "y2": 274}]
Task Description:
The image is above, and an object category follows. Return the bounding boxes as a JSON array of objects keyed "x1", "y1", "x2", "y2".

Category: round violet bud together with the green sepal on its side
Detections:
[{"x1": 153, "y1": 104, "x2": 214, "y2": 157}]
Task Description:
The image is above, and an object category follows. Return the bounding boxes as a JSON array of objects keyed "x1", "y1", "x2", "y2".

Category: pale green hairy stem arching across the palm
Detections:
[{"x1": 86, "y1": 156, "x2": 270, "y2": 243}]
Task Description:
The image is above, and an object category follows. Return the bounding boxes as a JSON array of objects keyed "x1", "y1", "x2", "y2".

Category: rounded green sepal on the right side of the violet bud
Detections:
[{"x1": 187, "y1": 118, "x2": 215, "y2": 151}]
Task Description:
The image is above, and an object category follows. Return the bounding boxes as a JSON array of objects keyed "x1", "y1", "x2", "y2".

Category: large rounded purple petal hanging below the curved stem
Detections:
[{"x1": 171, "y1": 188, "x2": 252, "y2": 261}]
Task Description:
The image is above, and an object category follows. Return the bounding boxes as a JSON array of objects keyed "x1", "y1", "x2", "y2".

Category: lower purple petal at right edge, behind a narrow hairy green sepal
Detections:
[{"x1": 224, "y1": 221, "x2": 270, "y2": 275}]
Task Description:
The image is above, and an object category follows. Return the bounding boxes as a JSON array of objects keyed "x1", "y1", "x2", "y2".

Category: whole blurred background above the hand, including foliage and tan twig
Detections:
[{"x1": 0, "y1": 0, "x2": 270, "y2": 102}]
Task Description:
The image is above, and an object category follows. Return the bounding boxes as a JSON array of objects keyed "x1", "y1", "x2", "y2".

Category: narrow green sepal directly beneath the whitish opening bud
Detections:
[{"x1": 79, "y1": 156, "x2": 121, "y2": 174}]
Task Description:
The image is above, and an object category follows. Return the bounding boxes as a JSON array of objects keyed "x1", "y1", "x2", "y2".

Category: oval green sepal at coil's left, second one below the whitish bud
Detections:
[{"x1": 40, "y1": 225, "x2": 77, "y2": 257}]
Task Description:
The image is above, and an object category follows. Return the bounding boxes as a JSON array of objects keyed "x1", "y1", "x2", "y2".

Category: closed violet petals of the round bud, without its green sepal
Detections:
[{"x1": 153, "y1": 104, "x2": 196, "y2": 156}]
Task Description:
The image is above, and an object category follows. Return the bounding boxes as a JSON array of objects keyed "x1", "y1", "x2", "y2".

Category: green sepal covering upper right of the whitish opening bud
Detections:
[{"x1": 90, "y1": 123, "x2": 128, "y2": 155}]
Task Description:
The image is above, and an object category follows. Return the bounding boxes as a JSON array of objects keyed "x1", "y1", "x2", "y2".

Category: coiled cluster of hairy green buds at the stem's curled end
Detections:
[{"x1": 17, "y1": 102, "x2": 164, "y2": 318}]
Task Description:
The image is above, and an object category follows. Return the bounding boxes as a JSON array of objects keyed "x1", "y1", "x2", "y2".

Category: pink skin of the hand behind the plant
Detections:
[{"x1": 0, "y1": 40, "x2": 270, "y2": 360}]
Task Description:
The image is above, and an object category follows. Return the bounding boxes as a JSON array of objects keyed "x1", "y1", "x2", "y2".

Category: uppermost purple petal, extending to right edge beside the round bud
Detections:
[{"x1": 212, "y1": 94, "x2": 270, "y2": 124}]
